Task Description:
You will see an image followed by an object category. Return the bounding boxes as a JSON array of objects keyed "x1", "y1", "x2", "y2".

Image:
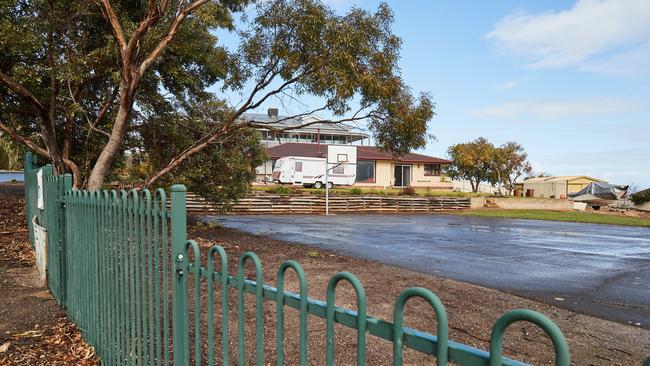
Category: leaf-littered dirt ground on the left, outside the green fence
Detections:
[{"x1": 0, "y1": 184, "x2": 97, "y2": 366}]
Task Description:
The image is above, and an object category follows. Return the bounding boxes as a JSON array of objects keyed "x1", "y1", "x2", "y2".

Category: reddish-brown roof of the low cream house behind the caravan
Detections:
[{"x1": 268, "y1": 142, "x2": 452, "y2": 164}]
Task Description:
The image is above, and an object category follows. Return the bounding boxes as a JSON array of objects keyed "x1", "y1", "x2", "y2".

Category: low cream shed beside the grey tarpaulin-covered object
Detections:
[{"x1": 523, "y1": 175, "x2": 607, "y2": 199}]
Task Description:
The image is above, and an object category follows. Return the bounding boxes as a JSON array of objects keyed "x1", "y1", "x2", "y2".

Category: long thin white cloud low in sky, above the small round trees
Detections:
[{"x1": 471, "y1": 97, "x2": 638, "y2": 119}]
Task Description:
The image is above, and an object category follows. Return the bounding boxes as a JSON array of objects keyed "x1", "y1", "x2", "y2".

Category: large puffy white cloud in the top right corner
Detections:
[{"x1": 487, "y1": 0, "x2": 650, "y2": 73}]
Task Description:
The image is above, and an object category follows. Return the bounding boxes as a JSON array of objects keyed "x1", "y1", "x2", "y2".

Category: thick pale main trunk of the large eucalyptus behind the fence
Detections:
[{"x1": 86, "y1": 79, "x2": 136, "y2": 190}]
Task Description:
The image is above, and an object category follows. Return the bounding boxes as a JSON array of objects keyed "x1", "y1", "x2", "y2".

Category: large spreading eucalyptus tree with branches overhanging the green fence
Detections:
[{"x1": 0, "y1": 0, "x2": 434, "y2": 193}]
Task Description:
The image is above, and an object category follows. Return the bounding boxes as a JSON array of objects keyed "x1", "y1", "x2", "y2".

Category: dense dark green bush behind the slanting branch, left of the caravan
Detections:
[{"x1": 142, "y1": 101, "x2": 266, "y2": 210}]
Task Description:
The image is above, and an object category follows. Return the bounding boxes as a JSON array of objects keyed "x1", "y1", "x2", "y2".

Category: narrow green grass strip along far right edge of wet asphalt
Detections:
[{"x1": 458, "y1": 209, "x2": 650, "y2": 227}]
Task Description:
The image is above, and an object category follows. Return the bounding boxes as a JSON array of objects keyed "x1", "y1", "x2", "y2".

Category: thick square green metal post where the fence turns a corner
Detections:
[{"x1": 170, "y1": 184, "x2": 187, "y2": 366}]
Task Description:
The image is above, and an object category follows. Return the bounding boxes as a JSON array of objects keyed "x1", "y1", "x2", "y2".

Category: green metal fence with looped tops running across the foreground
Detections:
[{"x1": 25, "y1": 155, "x2": 570, "y2": 366}]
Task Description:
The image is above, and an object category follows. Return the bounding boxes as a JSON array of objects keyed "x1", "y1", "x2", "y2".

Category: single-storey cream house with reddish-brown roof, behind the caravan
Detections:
[{"x1": 257, "y1": 142, "x2": 453, "y2": 190}]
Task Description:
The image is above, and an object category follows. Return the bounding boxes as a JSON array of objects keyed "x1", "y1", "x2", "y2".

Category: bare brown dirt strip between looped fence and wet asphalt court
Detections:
[{"x1": 188, "y1": 219, "x2": 650, "y2": 365}]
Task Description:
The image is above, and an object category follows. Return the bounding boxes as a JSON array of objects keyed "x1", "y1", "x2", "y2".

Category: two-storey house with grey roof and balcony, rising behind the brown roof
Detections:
[{"x1": 242, "y1": 108, "x2": 369, "y2": 147}]
